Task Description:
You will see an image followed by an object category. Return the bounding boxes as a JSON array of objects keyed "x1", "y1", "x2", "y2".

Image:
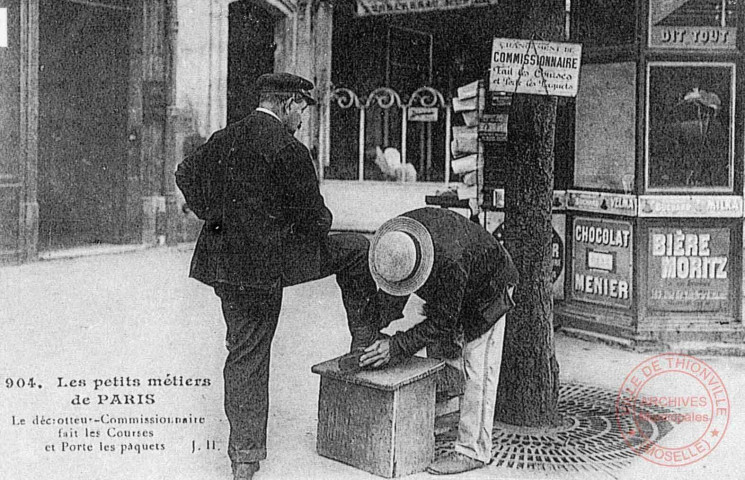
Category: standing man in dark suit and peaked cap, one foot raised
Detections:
[{"x1": 176, "y1": 73, "x2": 377, "y2": 480}]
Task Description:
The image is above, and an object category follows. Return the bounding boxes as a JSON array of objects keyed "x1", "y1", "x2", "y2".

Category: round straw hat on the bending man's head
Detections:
[{"x1": 368, "y1": 216, "x2": 435, "y2": 296}]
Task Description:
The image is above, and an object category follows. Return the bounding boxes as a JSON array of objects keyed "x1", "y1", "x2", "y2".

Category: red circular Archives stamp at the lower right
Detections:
[{"x1": 616, "y1": 353, "x2": 730, "y2": 467}]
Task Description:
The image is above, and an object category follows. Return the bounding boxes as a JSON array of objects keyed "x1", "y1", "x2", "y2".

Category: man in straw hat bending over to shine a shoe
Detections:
[{"x1": 360, "y1": 208, "x2": 518, "y2": 475}]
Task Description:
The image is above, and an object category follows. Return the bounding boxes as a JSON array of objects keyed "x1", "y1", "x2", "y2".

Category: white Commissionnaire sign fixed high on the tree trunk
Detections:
[{"x1": 489, "y1": 38, "x2": 582, "y2": 97}]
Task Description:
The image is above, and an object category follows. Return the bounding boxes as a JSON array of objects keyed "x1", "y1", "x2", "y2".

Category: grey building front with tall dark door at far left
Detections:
[{"x1": 0, "y1": 0, "x2": 177, "y2": 263}]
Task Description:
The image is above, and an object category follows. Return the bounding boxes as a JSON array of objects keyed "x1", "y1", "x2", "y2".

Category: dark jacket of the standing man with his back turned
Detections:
[{"x1": 176, "y1": 111, "x2": 332, "y2": 287}]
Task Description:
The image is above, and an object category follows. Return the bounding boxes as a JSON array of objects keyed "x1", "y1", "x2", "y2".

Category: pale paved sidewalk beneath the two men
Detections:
[{"x1": 0, "y1": 245, "x2": 745, "y2": 480}]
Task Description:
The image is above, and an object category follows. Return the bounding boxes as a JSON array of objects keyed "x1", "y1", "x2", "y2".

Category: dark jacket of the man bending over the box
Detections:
[{"x1": 391, "y1": 207, "x2": 519, "y2": 358}]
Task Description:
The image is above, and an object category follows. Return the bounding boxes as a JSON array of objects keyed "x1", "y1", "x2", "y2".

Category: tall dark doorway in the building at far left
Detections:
[{"x1": 38, "y1": 0, "x2": 130, "y2": 250}]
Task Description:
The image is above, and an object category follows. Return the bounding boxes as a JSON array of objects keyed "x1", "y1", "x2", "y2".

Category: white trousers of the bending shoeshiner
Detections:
[{"x1": 446, "y1": 317, "x2": 506, "y2": 463}]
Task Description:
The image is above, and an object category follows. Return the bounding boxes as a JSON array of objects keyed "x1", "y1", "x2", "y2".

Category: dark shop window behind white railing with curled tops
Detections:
[{"x1": 323, "y1": 22, "x2": 447, "y2": 182}]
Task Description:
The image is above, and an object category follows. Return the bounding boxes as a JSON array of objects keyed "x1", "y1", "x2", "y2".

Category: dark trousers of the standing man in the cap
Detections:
[{"x1": 215, "y1": 234, "x2": 377, "y2": 463}]
